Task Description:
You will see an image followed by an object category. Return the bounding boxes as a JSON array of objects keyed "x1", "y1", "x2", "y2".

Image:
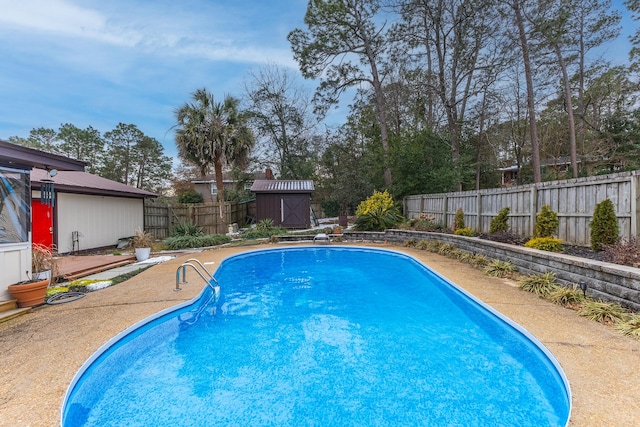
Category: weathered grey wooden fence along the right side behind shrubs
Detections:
[{"x1": 404, "y1": 171, "x2": 640, "y2": 246}]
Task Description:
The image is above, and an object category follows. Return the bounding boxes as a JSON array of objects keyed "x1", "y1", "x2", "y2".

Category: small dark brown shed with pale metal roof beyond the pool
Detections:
[{"x1": 251, "y1": 179, "x2": 314, "y2": 229}]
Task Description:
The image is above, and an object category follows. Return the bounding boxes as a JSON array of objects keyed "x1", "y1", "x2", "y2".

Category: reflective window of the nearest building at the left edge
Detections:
[{"x1": 0, "y1": 167, "x2": 31, "y2": 244}]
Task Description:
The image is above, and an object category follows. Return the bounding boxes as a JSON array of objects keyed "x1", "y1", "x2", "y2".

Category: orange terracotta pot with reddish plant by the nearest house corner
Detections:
[{"x1": 7, "y1": 243, "x2": 56, "y2": 307}]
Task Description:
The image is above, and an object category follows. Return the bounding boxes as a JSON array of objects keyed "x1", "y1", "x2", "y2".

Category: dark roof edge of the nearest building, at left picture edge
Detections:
[{"x1": 0, "y1": 140, "x2": 87, "y2": 171}]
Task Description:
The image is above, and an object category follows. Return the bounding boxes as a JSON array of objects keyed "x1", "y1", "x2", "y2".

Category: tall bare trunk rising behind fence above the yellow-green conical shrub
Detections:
[{"x1": 511, "y1": 0, "x2": 542, "y2": 182}]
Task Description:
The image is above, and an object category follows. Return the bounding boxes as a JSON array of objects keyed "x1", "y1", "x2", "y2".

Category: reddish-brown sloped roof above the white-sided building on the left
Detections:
[{"x1": 31, "y1": 169, "x2": 158, "y2": 199}]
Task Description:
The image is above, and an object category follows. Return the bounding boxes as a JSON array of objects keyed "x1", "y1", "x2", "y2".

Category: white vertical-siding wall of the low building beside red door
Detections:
[{"x1": 57, "y1": 193, "x2": 144, "y2": 253}]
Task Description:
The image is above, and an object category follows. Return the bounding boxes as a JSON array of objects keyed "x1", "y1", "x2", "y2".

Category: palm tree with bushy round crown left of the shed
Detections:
[{"x1": 175, "y1": 88, "x2": 255, "y2": 231}]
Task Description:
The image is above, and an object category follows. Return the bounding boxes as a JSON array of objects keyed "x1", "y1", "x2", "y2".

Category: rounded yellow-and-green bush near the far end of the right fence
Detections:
[{"x1": 355, "y1": 191, "x2": 404, "y2": 231}]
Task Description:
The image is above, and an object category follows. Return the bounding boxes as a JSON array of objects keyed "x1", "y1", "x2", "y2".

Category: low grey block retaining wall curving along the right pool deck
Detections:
[{"x1": 344, "y1": 230, "x2": 640, "y2": 311}]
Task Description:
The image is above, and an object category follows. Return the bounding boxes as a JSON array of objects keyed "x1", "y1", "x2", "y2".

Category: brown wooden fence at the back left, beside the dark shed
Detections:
[{"x1": 144, "y1": 201, "x2": 256, "y2": 239}]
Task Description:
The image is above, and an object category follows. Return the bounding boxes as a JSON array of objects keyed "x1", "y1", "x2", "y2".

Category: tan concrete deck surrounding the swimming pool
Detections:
[{"x1": 0, "y1": 244, "x2": 640, "y2": 427}]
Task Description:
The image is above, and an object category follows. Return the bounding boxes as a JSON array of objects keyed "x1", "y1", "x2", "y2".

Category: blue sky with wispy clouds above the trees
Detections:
[{"x1": 0, "y1": 0, "x2": 637, "y2": 164}]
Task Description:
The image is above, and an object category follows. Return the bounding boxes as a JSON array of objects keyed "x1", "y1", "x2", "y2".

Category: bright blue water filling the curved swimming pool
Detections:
[{"x1": 62, "y1": 246, "x2": 570, "y2": 426}]
